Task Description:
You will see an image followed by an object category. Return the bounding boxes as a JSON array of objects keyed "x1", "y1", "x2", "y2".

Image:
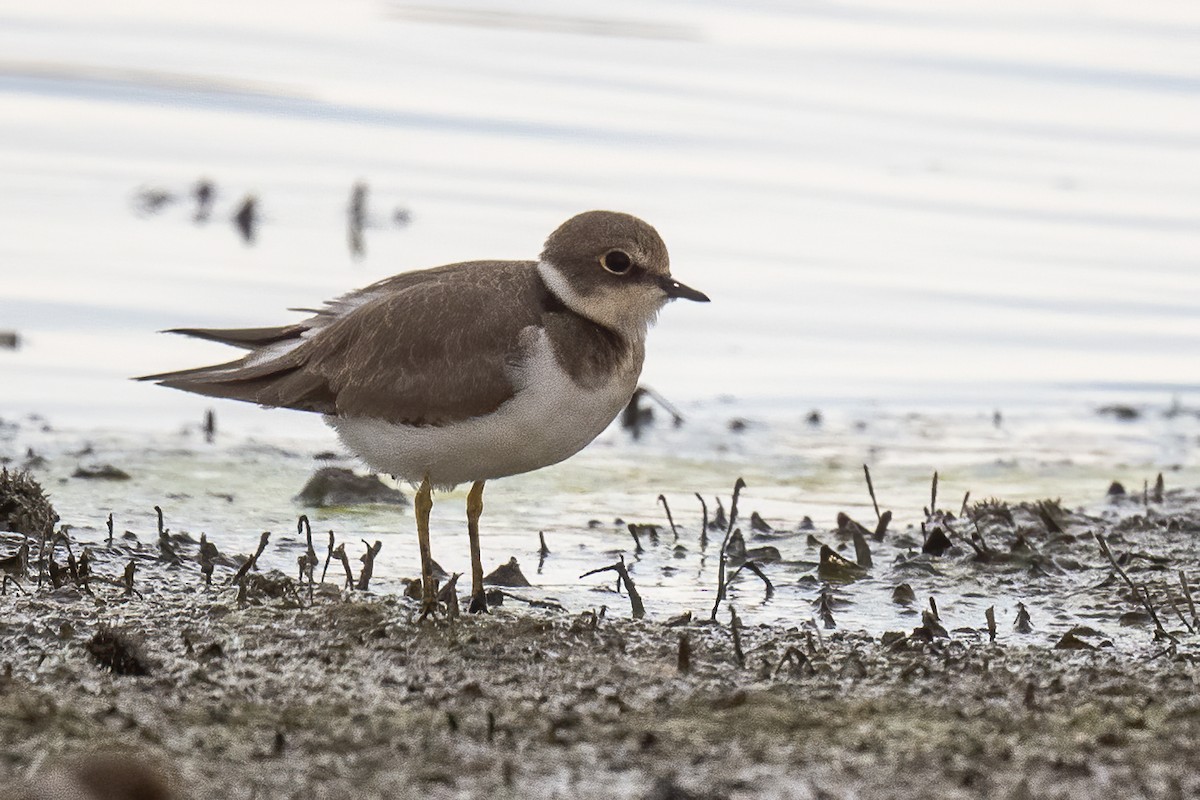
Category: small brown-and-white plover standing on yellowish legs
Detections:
[{"x1": 139, "y1": 211, "x2": 708, "y2": 615}]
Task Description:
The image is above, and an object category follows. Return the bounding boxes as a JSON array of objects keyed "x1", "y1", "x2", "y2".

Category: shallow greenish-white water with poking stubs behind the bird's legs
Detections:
[{"x1": 0, "y1": 395, "x2": 1200, "y2": 648}]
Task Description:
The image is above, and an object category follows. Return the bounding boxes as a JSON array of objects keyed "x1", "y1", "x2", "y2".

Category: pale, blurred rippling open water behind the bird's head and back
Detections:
[{"x1": 0, "y1": 0, "x2": 1200, "y2": 429}]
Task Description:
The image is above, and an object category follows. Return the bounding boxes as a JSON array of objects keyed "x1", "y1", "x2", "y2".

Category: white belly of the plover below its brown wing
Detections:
[{"x1": 325, "y1": 326, "x2": 641, "y2": 487}]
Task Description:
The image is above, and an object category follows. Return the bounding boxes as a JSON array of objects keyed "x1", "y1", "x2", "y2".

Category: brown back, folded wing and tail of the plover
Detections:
[{"x1": 145, "y1": 261, "x2": 548, "y2": 425}]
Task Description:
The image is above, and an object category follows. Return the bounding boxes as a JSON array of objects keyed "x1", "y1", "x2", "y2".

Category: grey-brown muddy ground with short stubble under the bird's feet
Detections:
[{"x1": 0, "y1": 472, "x2": 1200, "y2": 799}]
